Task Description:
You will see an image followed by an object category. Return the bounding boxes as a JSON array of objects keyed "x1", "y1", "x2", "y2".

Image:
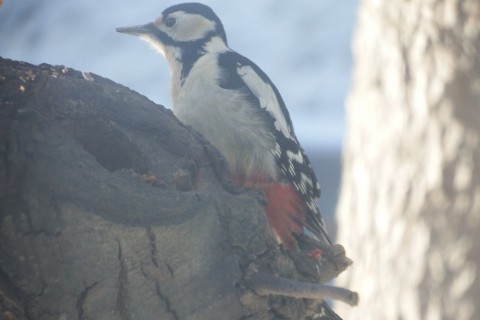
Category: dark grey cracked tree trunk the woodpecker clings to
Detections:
[{"x1": 0, "y1": 59, "x2": 330, "y2": 320}]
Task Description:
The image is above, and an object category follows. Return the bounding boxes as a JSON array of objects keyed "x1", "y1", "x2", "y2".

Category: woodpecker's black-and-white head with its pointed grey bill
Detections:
[{"x1": 116, "y1": 2, "x2": 227, "y2": 58}]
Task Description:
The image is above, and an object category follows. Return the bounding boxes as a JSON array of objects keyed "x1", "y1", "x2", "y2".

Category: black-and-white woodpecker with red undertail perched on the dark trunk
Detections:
[{"x1": 117, "y1": 3, "x2": 338, "y2": 270}]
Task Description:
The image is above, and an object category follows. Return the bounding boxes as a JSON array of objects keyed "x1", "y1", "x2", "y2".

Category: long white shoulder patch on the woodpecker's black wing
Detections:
[{"x1": 237, "y1": 65, "x2": 294, "y2": 140}]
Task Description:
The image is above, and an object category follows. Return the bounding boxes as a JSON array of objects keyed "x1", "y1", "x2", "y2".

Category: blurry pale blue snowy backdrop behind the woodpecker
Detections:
[{"x1": 0, "y1": 0, "x2": 357, "y2": 232}]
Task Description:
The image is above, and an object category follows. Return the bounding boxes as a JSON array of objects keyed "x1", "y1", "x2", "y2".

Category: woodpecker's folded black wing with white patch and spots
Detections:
[{"x1": 218, "y1": 51, "x2": 331, "y2": 244}]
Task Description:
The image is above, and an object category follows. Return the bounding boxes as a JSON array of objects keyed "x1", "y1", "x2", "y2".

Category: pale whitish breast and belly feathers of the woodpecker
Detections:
[{"x1": 172, "y1": 54, "x2": 278, "y2": 180}]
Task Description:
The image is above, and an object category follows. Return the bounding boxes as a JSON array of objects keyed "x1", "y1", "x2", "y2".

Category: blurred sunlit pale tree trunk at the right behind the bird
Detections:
[{"x1": 338, "y1": 0, "x2": 480, "y2": 320}]
